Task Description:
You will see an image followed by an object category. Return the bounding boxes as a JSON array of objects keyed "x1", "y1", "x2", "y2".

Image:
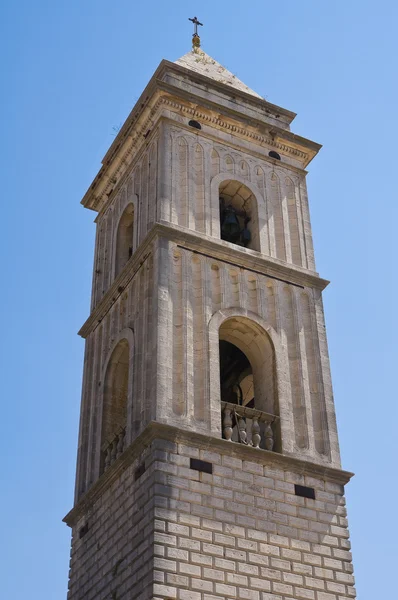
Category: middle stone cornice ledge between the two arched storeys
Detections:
[{"x1": 79, "y1": 222, "x2": 330, "y2": 338}]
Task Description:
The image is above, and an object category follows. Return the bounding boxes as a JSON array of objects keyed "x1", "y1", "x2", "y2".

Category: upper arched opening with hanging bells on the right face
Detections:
[{"x1": 219, "y1": 179, "x2": 260, "y2": 251}]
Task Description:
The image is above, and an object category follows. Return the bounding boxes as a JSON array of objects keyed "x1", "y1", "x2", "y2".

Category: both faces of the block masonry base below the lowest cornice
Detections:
[{"x1": 68, "y1": 436, "x2": 355, "y2": 600}]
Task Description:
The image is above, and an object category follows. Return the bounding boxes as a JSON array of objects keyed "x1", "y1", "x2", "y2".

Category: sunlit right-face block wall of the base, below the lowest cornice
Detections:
[{"x1": 154, "y1": 442, "x2": 355, "y2": 600}]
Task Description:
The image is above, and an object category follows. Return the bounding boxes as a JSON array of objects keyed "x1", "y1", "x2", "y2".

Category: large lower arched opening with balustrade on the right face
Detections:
[{"x1": 219, "y1": 316, "x2": 280, "y2": 451}]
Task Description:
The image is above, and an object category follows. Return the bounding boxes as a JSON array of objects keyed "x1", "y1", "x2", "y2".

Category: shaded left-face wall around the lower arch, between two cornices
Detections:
[{"x1": 76, "y1": 251, "x2": 157, "y2": 498}]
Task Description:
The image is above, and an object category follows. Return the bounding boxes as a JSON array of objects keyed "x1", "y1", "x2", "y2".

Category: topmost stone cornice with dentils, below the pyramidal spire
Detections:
[{"x1": 81, "y1": 60, "x2": 322, "y2": 211}]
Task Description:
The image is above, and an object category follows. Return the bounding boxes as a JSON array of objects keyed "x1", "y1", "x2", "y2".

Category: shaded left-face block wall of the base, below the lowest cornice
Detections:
[{"x1": 68, "y1": 440, "x2": 155, "y2": 600}]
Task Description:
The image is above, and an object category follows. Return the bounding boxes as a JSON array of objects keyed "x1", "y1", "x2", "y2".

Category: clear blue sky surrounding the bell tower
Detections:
[{"x1": 0, "y1": 0, "x2": 398, "y2": 600}]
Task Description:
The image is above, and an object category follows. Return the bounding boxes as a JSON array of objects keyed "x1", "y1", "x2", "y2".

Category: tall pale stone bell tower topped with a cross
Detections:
[{"x1": 65, "y1": 28, "x2": 355, "y2": 600}]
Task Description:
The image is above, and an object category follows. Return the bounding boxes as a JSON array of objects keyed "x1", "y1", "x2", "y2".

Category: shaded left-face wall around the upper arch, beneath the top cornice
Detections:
[{"x1": 92, "y1": 131, "x2": 158, "y2": 308}]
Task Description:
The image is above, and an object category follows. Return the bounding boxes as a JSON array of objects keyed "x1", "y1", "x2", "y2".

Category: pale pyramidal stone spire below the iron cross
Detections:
[{"x1": 175, "y1": 48, "x2": 261, "y2": 98}]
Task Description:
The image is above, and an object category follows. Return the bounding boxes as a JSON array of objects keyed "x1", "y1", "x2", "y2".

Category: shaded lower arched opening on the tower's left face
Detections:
[{"x1": 101, "y1": 339, "x2": 130, "y2": 471}]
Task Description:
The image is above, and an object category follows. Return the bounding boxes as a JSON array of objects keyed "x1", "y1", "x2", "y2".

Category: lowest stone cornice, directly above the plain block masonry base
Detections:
[{"x1": 63, "y1": 421, "x2": 353, "y2": 527}]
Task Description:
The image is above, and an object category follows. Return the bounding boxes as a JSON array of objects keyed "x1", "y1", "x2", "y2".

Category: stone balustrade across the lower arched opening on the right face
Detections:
[{"x1": 221, "y1": 402, "x2": 279, "y2": 450}]
